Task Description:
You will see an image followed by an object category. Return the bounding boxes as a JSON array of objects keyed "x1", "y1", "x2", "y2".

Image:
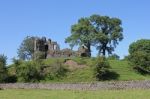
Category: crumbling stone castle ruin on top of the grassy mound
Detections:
[{"x1": 34, "y1": 37, "x2": 89, "y2": 59}]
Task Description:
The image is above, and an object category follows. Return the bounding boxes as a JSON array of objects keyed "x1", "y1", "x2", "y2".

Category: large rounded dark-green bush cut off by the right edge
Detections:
[{"x1": 129, "y1": 39, "x2": 150, "y2": 73}]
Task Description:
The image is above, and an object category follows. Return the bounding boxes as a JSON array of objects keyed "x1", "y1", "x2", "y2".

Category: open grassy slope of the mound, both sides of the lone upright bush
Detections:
[{"x1": 9, "y1": 58, "x2": 150, "y2": 83}]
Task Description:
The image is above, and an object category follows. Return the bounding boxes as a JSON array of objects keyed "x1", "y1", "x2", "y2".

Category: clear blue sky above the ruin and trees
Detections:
[{"x1": 0, "y1": 0, "x2": 150, "y2": 63}]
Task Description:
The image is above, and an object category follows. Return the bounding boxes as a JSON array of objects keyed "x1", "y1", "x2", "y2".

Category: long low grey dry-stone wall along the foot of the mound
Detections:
[{"x1": 0, "y1": 80, "x2": 150, "y2": 90}]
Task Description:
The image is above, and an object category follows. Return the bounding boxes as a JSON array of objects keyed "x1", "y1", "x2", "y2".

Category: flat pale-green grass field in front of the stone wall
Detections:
[{"x1": 0, "y1": 89, "x2": 150, "y2": 99}]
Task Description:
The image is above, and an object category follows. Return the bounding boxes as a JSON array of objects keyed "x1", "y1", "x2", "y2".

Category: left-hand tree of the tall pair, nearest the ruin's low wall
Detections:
[{"x1": 65, "y1": 18, "x2": 93, "y2": 56}]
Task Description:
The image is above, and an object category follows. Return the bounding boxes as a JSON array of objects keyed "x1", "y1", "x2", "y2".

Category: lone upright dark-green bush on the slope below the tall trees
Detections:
[{"x1": 96, "y1": 57, "x2": 110, "y2": 80}]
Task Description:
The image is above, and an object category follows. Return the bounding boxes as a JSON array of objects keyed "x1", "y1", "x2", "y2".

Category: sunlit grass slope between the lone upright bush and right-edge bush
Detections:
[{"x1": 109, "y1": 60, "x2": 150, "y2": 80}]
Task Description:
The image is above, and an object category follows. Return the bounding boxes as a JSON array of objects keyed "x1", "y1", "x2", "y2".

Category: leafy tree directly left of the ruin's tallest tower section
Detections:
[{"x1": 18, "y1": 36, "x2": 35, "y2": 60}]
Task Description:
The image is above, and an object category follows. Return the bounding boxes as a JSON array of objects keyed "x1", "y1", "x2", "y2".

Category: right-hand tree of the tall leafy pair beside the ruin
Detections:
[{"x1": 90, "y1": 15, "x2": 123, "y2": 56}]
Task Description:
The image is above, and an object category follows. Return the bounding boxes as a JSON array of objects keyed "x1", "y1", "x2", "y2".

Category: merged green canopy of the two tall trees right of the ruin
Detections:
[{"x1": 66, "y1": 15, "x2": 123, "y2": 56}]
